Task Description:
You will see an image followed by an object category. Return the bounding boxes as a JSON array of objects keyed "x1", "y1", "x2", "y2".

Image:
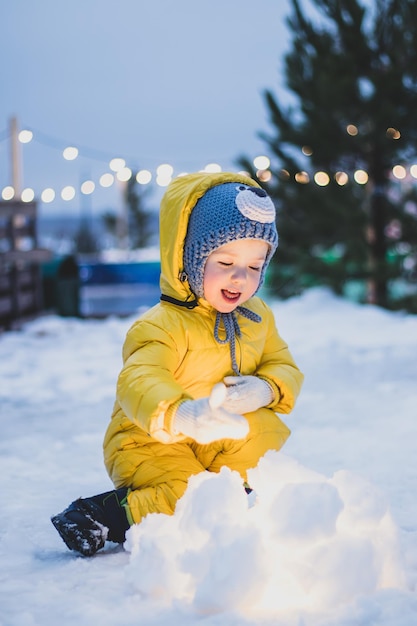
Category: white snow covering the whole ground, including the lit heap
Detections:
[{"x1": 0, "y1": 289, "x2": 417, "y2": 626}]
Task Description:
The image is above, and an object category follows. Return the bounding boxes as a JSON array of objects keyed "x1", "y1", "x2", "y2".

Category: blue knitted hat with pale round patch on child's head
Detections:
[{"x1": 184, "y1": 182, "x2": 278, "y2": 297}]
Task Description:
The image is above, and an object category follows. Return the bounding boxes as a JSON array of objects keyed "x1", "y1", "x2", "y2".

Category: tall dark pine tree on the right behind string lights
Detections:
[{"x1": 240, "y1": 0, "x2": 417, "y2": 310}]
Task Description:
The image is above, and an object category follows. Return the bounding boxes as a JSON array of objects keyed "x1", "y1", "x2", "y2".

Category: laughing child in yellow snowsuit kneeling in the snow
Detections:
[{"x1": 52, "y1": 173, "x2": 303, "y2": 556}]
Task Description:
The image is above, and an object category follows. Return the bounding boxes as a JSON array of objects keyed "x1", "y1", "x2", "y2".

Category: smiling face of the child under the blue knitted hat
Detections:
[{"x1": 203, "y1": 239, "x2": 269, "y2": 313}]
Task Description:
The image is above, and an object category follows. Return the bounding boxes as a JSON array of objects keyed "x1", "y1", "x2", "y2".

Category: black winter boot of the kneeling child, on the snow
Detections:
[{"x1": 51, "y1": 487, "x2": 130, "y2": 556}]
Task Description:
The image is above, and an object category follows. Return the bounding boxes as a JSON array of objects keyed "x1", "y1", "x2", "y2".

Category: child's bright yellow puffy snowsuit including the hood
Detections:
[{"x1": 104, "y1": 173, "x2": 303, "y2": 523}]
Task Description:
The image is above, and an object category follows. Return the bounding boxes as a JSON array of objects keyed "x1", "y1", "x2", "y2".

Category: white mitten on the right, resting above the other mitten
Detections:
[{"x1": 222, "y1": 376, "x2": 274, "y2": 413}]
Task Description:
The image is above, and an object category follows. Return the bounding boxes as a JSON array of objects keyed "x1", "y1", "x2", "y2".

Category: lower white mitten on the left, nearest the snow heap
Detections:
[{"x1": 174, "y1": 383, "x2": 249, "y2": 444}]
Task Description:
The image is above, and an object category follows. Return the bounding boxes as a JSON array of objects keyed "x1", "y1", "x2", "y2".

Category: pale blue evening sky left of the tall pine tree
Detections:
[{"x1": 0, "y1": 0, "x2": 290, "y2": 216}]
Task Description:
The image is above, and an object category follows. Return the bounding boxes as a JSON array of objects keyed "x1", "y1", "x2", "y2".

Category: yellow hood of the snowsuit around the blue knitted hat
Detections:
[{"x1": 159, "y1": 172, "x2": 260, "y2": 302}]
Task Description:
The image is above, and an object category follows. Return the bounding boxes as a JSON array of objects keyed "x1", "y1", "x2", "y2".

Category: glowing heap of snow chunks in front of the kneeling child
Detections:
[{"x1": 125, "y1": 452, "x2": 405, "y2": 617}]
